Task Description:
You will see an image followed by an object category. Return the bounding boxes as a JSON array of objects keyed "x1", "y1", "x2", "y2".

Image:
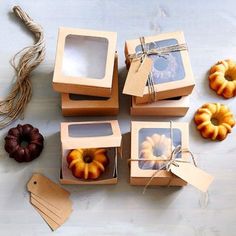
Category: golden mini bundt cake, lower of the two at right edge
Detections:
[{"x1": 194, "y1": 103, "x2": 235, "y2": 141}]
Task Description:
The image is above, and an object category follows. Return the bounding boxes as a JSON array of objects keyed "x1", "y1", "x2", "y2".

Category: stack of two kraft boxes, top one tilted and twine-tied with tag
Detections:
[{"x1": 123, "y1": 32, "x2": 195, "y2": 116}]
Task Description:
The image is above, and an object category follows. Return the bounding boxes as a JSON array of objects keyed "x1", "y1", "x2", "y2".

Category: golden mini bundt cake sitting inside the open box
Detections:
[{"x1": 67, "y1": 148, "x2": 108, "y2": 180}]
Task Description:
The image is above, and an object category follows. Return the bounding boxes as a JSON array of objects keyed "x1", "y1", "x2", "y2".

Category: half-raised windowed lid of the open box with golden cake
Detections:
[{"x1": 61, "y1": 120, "x2": 121, "y2": 149}]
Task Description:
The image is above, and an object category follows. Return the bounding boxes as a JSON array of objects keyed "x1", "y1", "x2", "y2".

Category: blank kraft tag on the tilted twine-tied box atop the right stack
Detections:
[{"x1": 123, "y1": 57, "x2": 153, "y2": 97}]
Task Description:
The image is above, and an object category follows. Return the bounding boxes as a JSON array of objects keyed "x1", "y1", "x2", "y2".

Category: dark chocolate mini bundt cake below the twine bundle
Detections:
[{"x1": 5, "y1": 124, "x2": 44, "y2": 162}]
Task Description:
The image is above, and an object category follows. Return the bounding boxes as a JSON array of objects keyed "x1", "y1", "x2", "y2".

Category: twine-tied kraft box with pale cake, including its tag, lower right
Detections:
[{"x1": 130, "y1": 121, "x2": 214, "y2": 192}]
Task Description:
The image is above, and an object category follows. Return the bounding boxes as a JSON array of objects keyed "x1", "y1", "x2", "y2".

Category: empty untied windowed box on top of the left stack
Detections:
[{"x1": 53, "y1": 27, "x2": 117, "y2": 97}]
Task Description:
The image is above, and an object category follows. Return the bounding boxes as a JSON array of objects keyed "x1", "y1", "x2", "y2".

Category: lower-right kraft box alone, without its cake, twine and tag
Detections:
[{"x1": 130, "y1": 121, "x2": 189, "y2": 186}]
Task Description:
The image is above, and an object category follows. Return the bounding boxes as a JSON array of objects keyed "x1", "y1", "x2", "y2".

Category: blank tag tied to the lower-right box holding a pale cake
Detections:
[{"x1": 170, "y1": 162, "x2": 214, "y2": 192}]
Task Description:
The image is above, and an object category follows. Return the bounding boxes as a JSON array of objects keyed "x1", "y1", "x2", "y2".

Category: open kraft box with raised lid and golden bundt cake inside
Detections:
[{"x1": 60, "y1": 120, "x2": 121, "y2": 184}]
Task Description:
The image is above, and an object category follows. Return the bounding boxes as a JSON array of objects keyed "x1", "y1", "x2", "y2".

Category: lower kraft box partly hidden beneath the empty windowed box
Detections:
[{"x1": 61, "y1": 54, "x2": 119, "y2": 116}]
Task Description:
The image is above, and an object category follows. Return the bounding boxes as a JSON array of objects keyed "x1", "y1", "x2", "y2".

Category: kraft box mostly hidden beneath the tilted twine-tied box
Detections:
[{"x1": 130, "y1": 96, "x2": 190, "y2": 116}]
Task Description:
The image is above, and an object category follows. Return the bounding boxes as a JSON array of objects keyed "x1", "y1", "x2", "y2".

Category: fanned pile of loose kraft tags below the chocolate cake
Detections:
[{"x1": 27, "y1": 174, "x2": 72, "y2": 230}]
